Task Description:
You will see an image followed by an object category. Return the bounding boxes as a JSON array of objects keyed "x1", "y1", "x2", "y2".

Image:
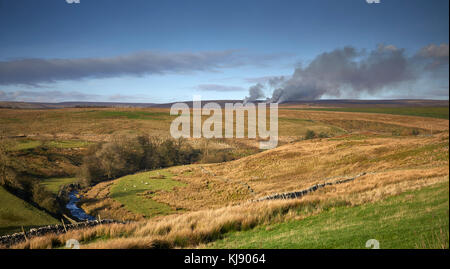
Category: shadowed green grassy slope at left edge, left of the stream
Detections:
[{"x1": 0, "y1": 187, "x2": 59, "y2": 234}]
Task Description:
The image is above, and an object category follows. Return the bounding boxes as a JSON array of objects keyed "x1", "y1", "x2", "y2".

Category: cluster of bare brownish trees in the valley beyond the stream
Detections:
[{"x1": 79, "y1": 135, "x2": 201, "y2": 185}]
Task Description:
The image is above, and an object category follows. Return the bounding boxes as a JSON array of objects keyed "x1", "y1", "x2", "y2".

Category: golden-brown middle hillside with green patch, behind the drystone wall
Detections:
[{"x1": 73, "y1": 127, "x2": 449, "y2": 220}]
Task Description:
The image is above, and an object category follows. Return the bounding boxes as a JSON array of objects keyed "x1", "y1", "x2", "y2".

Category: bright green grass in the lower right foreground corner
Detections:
[{"x1": 206, "y1": 182, "x2": 449, "y2": 249}]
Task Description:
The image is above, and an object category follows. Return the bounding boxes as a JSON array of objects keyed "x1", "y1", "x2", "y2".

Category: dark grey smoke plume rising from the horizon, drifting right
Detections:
[{"x1": 249, "y1": 44, "x2": 449, "y2": 103}]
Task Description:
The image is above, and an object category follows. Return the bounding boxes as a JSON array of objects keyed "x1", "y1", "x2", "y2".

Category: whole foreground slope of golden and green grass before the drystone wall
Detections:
[{"x1": 15, "y1": 171, "x2": 449, "y2": 248}]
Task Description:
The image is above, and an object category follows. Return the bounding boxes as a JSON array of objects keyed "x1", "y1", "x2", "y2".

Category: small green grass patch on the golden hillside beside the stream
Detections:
[{"x1": 110, "y1": 170, "x2": 184, "y2": 217}]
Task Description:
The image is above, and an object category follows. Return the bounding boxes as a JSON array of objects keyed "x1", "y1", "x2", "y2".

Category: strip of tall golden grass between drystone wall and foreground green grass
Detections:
[{"x1": 14, "y1": 173, "x2": 449, "y2": 248}]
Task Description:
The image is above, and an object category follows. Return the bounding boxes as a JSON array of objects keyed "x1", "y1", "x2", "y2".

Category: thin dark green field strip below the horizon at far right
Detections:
[{"x1": 285, "y1": 107, "x2": 449, "y2": 119}]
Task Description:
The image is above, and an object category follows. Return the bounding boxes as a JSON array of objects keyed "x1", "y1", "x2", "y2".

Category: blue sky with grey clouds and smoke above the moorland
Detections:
[{"x1": 0, "y1": 0, "x2": 449, "y2": 103}]
